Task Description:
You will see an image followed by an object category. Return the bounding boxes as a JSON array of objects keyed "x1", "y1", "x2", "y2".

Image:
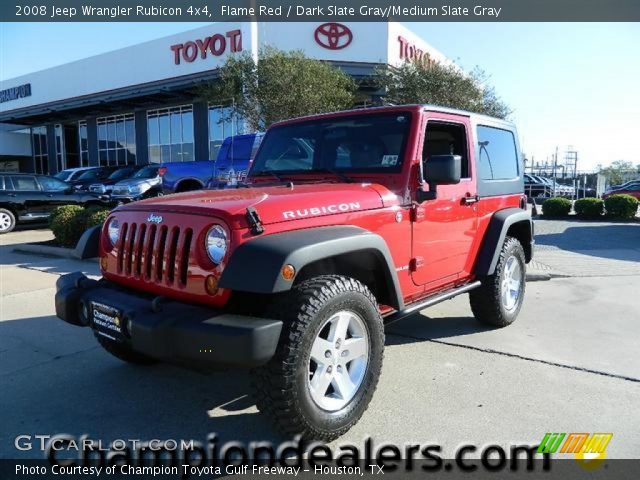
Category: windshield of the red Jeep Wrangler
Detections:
[{"x1": 250, "y1": 113, "x2": 411, "y2": 176}]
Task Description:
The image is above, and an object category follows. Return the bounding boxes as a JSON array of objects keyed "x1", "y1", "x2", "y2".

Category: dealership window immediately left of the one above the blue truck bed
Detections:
[{"x1": 97, "y1": 113, "x2": 136, "y2": 166}]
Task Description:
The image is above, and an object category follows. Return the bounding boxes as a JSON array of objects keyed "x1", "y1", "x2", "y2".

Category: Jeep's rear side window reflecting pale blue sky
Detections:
[{"x1": 478, "y1": 125, "x2": 519, "y2": 180}]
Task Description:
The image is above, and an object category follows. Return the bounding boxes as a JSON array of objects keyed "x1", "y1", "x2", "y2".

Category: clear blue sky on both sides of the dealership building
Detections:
[{"x1": 0, "y1": 23, "x2": 640, "y2": 169}]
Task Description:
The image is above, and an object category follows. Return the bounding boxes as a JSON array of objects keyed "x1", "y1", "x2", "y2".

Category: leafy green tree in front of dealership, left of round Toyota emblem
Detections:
[{"x1": 201, "y1": 48, "x2": 356, "y2": 131}]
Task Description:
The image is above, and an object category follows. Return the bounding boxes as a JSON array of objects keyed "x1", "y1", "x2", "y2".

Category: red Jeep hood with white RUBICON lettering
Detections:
[{"x1": 118, "y1": 183, "x2": 399, "y2": 228}]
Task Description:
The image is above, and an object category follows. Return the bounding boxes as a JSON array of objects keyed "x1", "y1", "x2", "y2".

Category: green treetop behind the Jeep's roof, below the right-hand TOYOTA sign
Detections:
[{"x1": 377, "y1": 62, "x2": 511, "y2": 118}]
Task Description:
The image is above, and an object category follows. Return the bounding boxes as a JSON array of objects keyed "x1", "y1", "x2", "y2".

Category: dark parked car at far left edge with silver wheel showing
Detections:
[{"x1": 0, "y1": 173, "x2": 106, "y2": 233}]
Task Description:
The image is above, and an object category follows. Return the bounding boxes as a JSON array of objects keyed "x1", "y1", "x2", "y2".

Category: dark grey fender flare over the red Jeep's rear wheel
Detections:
[{"x1": 474, "y1": 207, "x2": 534, "y2": 276}]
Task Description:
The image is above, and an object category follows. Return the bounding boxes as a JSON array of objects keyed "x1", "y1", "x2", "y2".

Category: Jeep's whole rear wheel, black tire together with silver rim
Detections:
[{"x1": 469, "y1": 237, "x2": 526, "y2": 327}]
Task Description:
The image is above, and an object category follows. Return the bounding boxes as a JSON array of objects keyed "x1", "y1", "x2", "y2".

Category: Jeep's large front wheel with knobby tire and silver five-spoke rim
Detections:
[{"x1": 252, "y1": 276, "x2": 384, "y2": 441}]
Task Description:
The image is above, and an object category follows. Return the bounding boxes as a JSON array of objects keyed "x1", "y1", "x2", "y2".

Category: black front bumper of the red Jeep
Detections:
[{"x1": 56, "y1": 272, "x2": 282, "y2": 369}]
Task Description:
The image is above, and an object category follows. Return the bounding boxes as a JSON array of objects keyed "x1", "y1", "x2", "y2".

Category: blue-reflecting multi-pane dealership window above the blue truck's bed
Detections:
[{"x1": 147, "y1": 105, "x2": 194, "y2": 163}]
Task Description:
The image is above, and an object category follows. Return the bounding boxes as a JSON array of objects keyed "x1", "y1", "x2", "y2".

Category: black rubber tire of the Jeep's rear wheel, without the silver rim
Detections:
[{"x1": 469, "y1": 237, "x2": 526, "y2": 327}]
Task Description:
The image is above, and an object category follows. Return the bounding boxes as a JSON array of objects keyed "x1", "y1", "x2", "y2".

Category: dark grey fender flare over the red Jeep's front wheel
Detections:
[{"x1": 219, "y1": 226, "x2": 404, "y2": 310}]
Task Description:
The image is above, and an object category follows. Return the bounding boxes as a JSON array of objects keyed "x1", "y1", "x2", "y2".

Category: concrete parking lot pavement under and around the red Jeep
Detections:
[{"x1": 0, "y1": 227, "x2": 640, "y2": 458}]
